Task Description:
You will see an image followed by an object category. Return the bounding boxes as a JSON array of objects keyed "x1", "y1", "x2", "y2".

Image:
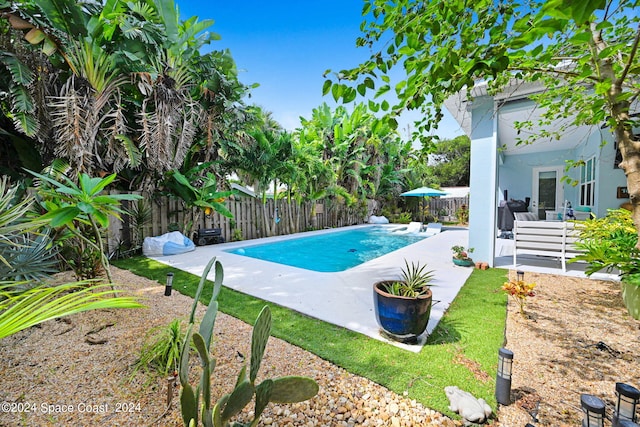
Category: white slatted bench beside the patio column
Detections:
[{"x1": 513, "y1": 220, "x2": 581, "y2": 271}]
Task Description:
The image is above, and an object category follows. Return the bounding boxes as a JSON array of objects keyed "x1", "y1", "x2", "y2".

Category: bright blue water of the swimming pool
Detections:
[{"x1": 226, "y1": 227, "x2": 424, "y2": 272}]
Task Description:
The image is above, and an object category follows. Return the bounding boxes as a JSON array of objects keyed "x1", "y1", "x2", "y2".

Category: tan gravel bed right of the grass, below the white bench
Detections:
[{"x1": 499, "y1": 271, "x2": 640, "y2": 427}]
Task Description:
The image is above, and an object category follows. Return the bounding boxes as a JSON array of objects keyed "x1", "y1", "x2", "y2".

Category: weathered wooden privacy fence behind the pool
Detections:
[{"x1": 108, "y1": 191, "x2": 366, "y2": 252}]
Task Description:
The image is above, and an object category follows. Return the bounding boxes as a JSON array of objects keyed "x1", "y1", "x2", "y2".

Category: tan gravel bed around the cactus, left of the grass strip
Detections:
[{"x1": 0, "y1": 268, "x2": 461, "y2": 427}]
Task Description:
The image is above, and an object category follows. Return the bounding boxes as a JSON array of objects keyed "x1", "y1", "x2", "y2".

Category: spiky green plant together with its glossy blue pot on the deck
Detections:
[{"x1": 373, "y1": 260, "x2": 433, "y2": 343}]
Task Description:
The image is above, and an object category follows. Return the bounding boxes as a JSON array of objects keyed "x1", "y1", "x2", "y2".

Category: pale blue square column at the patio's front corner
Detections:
[{"x1": 469, "y1": 97, "x2": 497, "y2": 265}]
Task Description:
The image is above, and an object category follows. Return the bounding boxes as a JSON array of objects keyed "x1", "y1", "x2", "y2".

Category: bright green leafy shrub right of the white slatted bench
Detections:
[{"x1": 569, "y1": 209, "x2": 640, "y2": 275}]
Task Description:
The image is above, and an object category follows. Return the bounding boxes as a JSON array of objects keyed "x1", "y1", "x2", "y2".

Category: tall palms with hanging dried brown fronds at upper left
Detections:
[{"x1": 0, "y1": 0, "x2": 248, "y2": 191}]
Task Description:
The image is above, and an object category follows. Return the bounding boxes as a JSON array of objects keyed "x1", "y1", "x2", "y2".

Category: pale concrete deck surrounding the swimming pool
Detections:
[{"x1": 152, "y1": 225, "x2": 473, "y2": 352}]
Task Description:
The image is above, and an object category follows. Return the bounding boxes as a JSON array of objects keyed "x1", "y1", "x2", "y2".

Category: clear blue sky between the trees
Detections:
[{"x1": 176, "y1": 0, "x2": 462, "y2": 138}]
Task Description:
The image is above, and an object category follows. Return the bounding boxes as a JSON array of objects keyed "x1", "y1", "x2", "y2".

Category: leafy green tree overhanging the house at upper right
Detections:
[{"x1": 324, "y1": 0, "x2": 640, "y2": 246}]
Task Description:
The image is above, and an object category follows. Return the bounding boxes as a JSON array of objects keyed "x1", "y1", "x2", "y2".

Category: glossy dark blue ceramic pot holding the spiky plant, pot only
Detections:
[{"x1": 373, "y1": 281, "x2": 433, "y2": 342}]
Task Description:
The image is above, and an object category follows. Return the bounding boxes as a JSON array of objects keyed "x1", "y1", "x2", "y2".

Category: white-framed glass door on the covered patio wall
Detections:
[{"x1": 531, "y1": 166, "x2": 564, "y2": 221}]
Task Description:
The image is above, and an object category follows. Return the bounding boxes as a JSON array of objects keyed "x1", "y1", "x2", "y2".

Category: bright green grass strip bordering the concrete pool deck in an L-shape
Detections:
[{"x1": 114, "y1": 257, "x2": 507, "y2": 415}]
